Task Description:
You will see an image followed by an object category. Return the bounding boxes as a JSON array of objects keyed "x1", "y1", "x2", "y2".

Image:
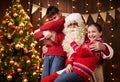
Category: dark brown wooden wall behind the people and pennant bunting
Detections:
[{"x1": 0, "y1": 0, "x2": 120, "y2": 82}]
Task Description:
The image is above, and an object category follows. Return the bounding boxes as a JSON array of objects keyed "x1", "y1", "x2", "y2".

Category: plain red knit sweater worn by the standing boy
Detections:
[{"x1": 34, "y1": 17, "x2": 66, "y2": 56}]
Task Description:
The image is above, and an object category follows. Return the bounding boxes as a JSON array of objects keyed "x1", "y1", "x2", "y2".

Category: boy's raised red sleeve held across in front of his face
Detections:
[{"x1": 40, "y1": 17, "x2": 65, "y2": 31}]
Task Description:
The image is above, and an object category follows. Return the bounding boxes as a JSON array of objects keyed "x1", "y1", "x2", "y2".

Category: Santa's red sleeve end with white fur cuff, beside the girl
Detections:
[{"x1": 102, "y1": 43, "x2": 114, "y2": 60}]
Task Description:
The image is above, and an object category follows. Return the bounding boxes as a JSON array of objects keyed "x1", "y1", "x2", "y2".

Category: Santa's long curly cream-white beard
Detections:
[{"x1": 62, "y1": 27, "x2": 86, "y2": 58}]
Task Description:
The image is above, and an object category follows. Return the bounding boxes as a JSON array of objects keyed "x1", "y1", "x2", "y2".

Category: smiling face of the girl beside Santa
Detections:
[{"x1": 87, "y1": 25, "x2": 102, "y2": 41}]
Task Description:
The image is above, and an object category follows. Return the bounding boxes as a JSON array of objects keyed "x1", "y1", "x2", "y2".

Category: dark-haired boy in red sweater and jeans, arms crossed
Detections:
[{"x1": 34, "y1": 6, "x2": 66, "y2": 78}]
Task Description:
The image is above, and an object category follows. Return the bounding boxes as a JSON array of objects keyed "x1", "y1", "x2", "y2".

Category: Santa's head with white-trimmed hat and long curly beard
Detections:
[{"x1": 62, "y1": 13, "x2": 86, "y2": 57}]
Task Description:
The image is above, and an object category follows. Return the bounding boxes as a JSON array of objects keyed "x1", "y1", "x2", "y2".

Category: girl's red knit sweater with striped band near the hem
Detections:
[{"x1": 67, "y1": 39, "x2": 101, "y2": 82}]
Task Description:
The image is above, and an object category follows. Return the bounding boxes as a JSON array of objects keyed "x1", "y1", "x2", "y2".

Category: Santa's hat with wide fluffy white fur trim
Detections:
[{"x1": 65, "y1": 13, "x2": 85, "y2": 26}]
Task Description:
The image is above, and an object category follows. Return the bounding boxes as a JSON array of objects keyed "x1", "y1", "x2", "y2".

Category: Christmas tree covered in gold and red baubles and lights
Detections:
[{"x1": 0, "y1": 0, "x2": 42, "y2": 82}]
